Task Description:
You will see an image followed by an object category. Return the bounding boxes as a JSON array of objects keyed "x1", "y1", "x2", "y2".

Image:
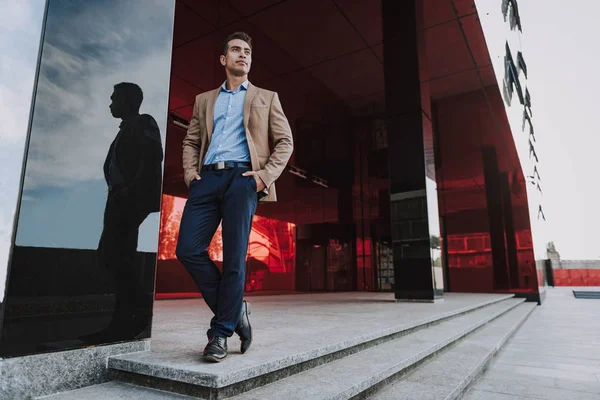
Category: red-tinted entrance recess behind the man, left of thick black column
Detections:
[{"x1": 156, "y1": 1, "x2": 393, "y2": 297}]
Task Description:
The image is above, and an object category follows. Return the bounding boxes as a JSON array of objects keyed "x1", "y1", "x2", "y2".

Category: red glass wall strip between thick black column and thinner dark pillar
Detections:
[{"x1": 432, "y1": 91, "x2": 494, "y2": 292}]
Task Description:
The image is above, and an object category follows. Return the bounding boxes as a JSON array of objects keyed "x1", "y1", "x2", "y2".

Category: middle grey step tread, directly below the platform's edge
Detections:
[{"x1": 225, "y1": 299, "x2": 524, "y2": 400}]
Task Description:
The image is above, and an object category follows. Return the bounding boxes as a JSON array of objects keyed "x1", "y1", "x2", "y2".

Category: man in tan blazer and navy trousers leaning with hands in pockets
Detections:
[{"x1": 177, "y1": 32, "x2": 293, "y2": 362}]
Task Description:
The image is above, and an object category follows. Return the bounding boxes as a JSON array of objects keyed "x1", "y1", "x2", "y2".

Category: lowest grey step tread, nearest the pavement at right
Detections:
[{"x1": 368, "y1": 303, "x2": 537, "y2": 400}]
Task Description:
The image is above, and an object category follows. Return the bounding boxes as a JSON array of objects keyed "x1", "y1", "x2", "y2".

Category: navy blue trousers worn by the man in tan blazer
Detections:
[{"x1": 176, "y1": 168, "x2": 258, "y2": 337}]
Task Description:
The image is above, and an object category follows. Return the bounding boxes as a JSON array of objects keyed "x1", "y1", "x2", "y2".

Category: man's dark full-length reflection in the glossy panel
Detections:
[{"x1": 82, "y1": 82, "x2": 163, "y2": 343}]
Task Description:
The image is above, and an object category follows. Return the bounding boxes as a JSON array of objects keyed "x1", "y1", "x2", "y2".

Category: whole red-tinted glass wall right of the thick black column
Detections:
[{"x1": 436, "y1": 87, "x2": 537, "y2": 292}]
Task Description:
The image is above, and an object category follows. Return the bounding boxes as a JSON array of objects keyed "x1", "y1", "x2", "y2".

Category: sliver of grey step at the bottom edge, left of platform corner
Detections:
[{"x1": 37, "y1": 382, "x2": 194, "y2": 400}]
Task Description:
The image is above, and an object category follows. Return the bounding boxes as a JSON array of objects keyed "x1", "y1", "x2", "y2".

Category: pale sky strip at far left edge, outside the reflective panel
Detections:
[{"x1": 0, "y1": 0, "x2": 46, "y2": 330}]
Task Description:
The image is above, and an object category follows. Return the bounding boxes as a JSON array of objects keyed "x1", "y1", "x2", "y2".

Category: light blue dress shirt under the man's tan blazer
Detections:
[{"x1": 204, "y1": 80, "x2": 250, "y2": 165}]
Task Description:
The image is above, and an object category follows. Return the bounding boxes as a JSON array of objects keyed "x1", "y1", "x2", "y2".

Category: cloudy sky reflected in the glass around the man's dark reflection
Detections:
[{"x1": 17, "y1": 0, "x2": 174, "y2": 252}]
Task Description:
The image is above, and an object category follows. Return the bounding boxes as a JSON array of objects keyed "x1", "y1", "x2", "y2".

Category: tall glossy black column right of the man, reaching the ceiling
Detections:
[{"x1": 382, "y1": 0, "x2": 443, "y2": 301}]
